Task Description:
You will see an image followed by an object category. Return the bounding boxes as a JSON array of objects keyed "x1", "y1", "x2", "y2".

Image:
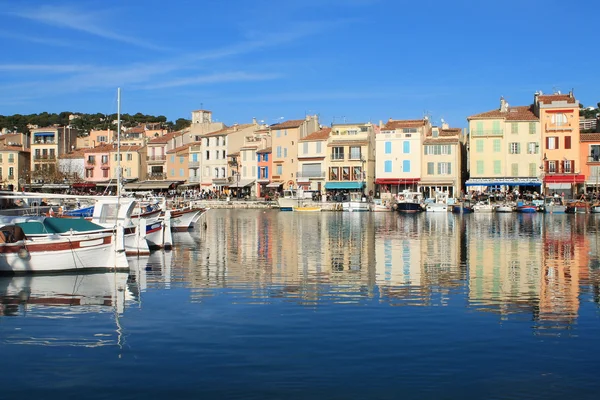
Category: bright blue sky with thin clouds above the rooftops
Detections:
[{"x1": 0, "y1": 0, "x2": 600, "y2": 127}]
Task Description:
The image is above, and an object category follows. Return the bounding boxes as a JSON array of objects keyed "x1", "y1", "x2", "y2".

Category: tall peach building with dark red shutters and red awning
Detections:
[{"x1": 534, "y1": 92, "x2": 585, "y2": 197}]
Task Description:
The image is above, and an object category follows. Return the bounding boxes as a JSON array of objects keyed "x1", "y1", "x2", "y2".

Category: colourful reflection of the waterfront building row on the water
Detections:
[{"x1": 162, "y1": 210, "x2": 600, "y2": 330}]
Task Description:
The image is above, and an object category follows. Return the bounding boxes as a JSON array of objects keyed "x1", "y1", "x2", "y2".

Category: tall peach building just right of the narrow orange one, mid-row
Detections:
[{"x1": 269, "y1": 115, "x2": 319, "y2": 189}]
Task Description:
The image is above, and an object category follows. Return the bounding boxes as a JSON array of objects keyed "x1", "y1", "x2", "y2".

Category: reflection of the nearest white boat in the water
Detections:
[{"x1": 0, "y1": 272, "x2": 135, "y2": 347}]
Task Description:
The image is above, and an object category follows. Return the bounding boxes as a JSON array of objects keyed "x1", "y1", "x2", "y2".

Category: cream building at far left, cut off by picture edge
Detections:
[{"x1": 0, "y1": 141, "x2": 31, "y2": 191}]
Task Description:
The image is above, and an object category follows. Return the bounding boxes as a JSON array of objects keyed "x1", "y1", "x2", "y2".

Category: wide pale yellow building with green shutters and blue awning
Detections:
[{"x1": 466, "y1": 97, "x2": 543, "y2": 193}]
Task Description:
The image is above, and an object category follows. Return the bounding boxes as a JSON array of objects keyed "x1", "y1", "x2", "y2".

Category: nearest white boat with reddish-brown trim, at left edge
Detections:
[{"x1": 0, "y1": 222, "x2": 129, "y2": 274}]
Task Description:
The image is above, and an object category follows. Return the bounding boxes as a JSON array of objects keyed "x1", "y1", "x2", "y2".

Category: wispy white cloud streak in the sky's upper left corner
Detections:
[{"x1": 7, "y1": 6, "x2": 165, "y2": 50}]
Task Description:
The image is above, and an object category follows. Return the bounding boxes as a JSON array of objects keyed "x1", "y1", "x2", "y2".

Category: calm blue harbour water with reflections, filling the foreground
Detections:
[{"x1": 0, "y1": 210, "x2": 600, "y2": 399}]
